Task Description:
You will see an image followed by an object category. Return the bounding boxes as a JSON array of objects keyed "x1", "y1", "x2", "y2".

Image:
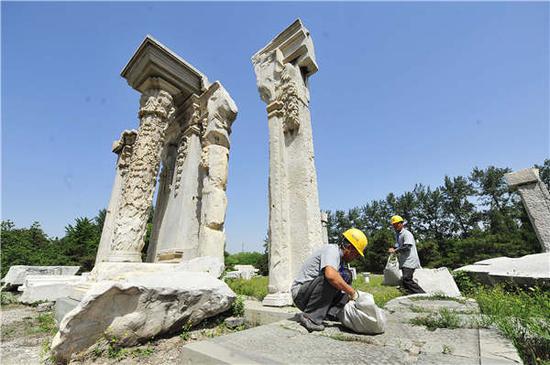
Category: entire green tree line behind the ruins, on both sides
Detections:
[{"x1": 0, "y1": 159, "x2": 550, "y2": 276}]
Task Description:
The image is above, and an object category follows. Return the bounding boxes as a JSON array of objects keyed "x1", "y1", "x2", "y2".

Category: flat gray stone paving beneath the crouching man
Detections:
[{"x1": 179, "y1": 296, "x2": 521, "y2": 365}]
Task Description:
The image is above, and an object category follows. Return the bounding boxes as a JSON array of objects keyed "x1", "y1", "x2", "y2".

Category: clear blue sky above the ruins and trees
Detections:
[{"x1": 1, "y1": 2, "x2": 550, "y2": 252}]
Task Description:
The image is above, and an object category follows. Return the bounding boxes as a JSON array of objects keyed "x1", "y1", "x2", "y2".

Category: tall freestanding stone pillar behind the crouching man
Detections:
[{"x1": 252, "y1": 20, "x2": 324, "y2": 306}]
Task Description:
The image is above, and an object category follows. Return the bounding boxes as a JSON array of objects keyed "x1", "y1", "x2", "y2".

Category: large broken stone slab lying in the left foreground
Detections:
[{"x1": 52, "y1": 271, "x2": 236, "y2": 363}]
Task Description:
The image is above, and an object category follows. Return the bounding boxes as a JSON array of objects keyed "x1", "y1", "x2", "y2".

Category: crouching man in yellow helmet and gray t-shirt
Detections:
[{"x1": 291, "y1": 228, "x2": 368, "y2": 332}]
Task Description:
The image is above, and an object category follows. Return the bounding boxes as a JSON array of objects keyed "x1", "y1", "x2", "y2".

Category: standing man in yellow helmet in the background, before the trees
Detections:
[{"x1": 388, "y1": 215, "x2": 425, "y2": 294}]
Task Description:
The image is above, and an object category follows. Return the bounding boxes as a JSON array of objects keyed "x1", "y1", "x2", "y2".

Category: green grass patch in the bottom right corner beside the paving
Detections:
[{"x1": 471, "y1": 286, "x2": 550, "y2": 365}]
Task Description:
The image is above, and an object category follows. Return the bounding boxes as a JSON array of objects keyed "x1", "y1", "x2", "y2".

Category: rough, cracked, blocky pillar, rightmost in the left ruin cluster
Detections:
[{"x1": 199, "y1": 82, "x2": 237, "y2": 262}]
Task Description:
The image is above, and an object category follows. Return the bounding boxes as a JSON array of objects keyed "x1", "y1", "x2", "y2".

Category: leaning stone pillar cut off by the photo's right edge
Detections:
[{"x1": 505, "y1": 169, "x2": 550, "y2": 252}]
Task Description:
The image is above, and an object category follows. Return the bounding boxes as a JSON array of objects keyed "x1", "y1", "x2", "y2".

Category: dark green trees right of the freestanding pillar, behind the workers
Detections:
[{"x1": 327, "y1": 159, "x2": 550, "y2": 272}]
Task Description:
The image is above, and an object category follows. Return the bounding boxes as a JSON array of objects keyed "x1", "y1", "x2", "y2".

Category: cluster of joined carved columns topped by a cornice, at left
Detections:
[{"x1": 96, "y1": 36, "x2": 237, "y2": 263}]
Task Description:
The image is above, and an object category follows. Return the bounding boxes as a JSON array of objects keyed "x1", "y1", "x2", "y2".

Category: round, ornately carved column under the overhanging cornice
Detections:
[{"x1": 109, "y1": 86, "x2": 174, "y2": 262}]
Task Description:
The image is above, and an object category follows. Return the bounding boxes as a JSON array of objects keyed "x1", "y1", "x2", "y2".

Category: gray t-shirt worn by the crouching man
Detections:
[{"x1": 290, "y1": 244, "x2": 342, "y2": 298}]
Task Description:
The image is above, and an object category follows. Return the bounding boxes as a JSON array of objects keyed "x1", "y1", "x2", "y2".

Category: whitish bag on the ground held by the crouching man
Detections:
[{"x1": 338, "y1": 292, "x2": 386, "y2": 335}]
